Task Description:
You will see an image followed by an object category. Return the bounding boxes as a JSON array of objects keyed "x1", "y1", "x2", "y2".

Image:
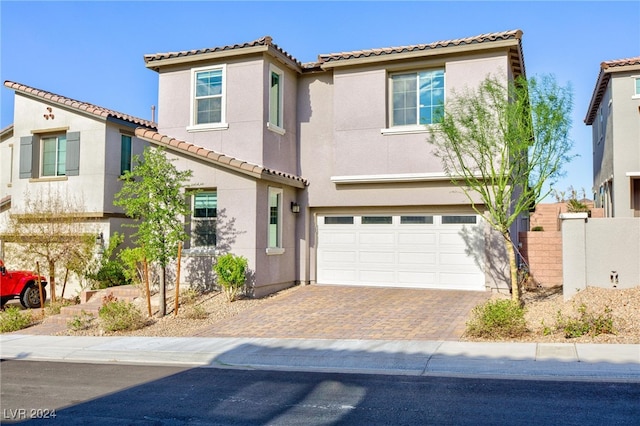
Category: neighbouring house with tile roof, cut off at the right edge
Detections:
[{"x1": 584, "y1": 57, "x2": 640, "y2": 217}]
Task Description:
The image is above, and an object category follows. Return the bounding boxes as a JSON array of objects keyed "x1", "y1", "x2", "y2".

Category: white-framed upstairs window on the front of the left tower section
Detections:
[{"x1": 192, "y1": 67, "x2": 225, "y2": 127}]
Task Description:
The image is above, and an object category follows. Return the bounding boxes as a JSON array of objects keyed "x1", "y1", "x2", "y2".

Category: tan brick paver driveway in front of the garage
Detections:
[{"x1": 197, "y1": 285, "x2": 490, "y2": 340}]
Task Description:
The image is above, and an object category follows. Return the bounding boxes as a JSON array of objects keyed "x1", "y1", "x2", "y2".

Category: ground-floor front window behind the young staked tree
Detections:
[{"x1": 191, "y1": 191, "x2": 218, "y2": 248}]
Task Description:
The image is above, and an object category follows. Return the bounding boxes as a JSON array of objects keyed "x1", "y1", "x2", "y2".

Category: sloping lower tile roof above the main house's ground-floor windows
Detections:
[{"x1": 135, "y1": 127, "x2": 308, "y2": 188}]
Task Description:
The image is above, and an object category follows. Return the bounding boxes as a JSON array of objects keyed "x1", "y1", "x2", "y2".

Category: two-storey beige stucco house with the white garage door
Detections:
[{"x1": 0, "y1": 31, "x2": 524, "y2": 296}]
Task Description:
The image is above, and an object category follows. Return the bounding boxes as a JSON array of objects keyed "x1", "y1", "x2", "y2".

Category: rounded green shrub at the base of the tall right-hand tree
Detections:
[{"x1": 467, "y1": 299, "x2": 527, "y2": 338}]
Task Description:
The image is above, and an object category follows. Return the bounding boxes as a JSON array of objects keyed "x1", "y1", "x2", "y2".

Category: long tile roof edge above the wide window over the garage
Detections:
[{"x1": 318, "y1": 30, "x2": 522, "y2": 63}]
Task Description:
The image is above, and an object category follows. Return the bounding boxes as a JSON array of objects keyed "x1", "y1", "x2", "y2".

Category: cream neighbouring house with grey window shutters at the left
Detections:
[{"x1": 0, "y1": 81, "x2": 155, "y2": 294}]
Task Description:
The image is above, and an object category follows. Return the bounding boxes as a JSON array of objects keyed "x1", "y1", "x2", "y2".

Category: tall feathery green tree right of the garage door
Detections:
[{"x1": 430, "y1": 75, "x2": 572, "y2": 302}]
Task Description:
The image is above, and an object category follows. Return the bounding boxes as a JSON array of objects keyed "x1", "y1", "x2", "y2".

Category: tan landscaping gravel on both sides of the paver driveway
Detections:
[{"x1": 56, "y1": 286, "x2": 640, "y2": 344}]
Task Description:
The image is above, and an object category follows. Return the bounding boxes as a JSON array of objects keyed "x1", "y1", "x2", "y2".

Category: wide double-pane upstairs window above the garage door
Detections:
[{"x1": 391, "y1": 70, "x2": 444, "y2": 126}]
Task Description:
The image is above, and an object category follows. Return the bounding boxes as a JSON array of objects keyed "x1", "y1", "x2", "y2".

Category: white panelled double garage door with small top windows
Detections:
[{"x1": 317, "y1": 215, "x2": 485, "y2": 291}]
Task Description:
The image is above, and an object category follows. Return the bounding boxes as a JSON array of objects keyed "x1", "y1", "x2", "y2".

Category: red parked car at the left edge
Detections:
[{"x1": 0, "y1": 259, "x2": 47, "y2": 308}]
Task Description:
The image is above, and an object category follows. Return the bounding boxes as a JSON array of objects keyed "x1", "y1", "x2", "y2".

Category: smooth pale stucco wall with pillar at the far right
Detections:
[{"x1": 561, "y1": 213, "x2": 640, "y2": 299}]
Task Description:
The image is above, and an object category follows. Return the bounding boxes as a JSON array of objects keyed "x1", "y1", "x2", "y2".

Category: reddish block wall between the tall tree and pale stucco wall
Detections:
[{"x1": 519, "y1": 231, "x2": 562, "y2": 287}]
